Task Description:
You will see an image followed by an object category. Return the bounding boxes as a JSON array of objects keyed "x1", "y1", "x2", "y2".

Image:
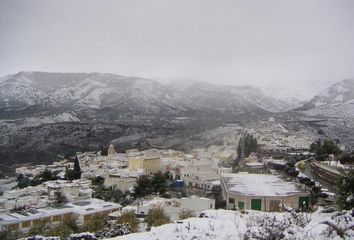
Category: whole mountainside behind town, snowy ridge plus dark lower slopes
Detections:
[{"x1": 0, "y1": 72, "x2": 290, "y2": 172}]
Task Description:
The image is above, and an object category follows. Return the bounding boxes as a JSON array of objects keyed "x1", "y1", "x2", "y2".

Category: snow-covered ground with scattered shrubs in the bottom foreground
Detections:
[{"x1": 108, "y1": 210, "x2": 354, "y2": 240}]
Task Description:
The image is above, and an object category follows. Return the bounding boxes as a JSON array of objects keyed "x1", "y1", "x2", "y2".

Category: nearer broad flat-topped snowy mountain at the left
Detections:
[{"x1": 0, "y1": 72, "x2": 191, "y2": 117}]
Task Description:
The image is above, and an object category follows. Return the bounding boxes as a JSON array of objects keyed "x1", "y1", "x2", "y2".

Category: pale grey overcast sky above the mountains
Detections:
[{"x1": 0, "y1": 0, "x2": 354, "y2": 97}]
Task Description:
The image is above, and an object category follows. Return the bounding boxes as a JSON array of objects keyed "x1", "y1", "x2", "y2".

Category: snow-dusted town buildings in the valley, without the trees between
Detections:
[{"x1": 0, "y1": 119, "x2": 318, "y2": 230}]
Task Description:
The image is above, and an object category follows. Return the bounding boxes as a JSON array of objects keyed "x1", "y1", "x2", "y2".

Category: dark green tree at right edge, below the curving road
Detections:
[{"x1": 337, "y1": 169, "x2": 354, "y2": 210}]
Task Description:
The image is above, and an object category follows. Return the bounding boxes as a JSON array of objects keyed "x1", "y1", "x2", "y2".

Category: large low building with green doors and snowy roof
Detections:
[{"x1": 221, "y1": 173, "x2": 309, "y2": 211}]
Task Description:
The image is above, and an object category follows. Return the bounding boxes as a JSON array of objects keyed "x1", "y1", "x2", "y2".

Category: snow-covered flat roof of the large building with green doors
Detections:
[{"x1": 222, "y1": 173, "x2": 304, "y2": 196}]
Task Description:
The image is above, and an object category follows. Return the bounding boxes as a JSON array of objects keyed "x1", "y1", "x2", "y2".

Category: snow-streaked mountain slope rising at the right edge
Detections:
[{"x1": 300, "y1": 79, "x2": 354, "y2": 118}]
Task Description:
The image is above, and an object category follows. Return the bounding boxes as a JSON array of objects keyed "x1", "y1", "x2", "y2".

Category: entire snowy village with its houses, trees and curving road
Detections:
[{"x1": 0, "y1": 118, "x2": 354, "y2": 239}]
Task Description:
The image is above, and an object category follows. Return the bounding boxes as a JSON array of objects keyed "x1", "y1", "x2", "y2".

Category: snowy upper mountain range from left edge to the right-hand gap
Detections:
[{"x1": 0, "y1": 72, "x2": 294, "y2": 118}]
